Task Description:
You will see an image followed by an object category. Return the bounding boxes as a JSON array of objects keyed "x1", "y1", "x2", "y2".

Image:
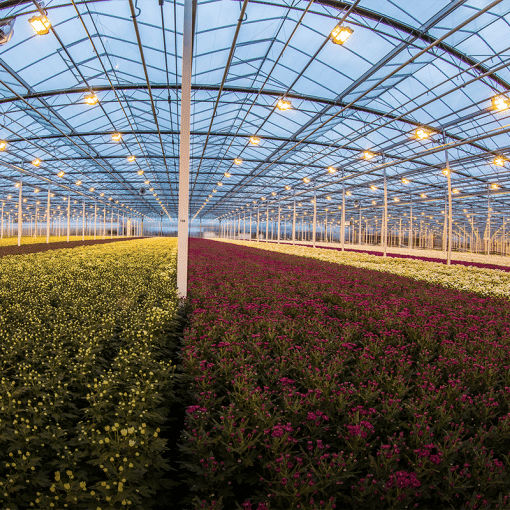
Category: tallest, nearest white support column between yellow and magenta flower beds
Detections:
[{"x1": 177, "y1": 0, "x2": 193, "y2": 298}]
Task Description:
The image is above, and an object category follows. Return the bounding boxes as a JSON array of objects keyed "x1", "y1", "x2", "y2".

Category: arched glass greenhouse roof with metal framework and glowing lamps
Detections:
[{"x1": 0, "y1": 0, "x2": 510, "y2": 228}]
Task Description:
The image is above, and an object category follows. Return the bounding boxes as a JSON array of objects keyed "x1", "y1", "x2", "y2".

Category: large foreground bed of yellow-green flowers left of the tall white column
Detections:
[{"x1": 0, "y1": 239, "x2": 177, "y2": 510}]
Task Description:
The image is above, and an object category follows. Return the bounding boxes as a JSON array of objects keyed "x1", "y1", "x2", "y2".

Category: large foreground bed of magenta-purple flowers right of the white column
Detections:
[{"x1": 182, "y1": 240, "x2": 510, "y2": 510}]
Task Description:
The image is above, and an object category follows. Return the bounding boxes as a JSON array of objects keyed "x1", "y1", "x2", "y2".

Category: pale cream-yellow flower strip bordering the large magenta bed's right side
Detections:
[{"x1": 224, "y1": 241, "x2": 510, "y2": 298}]
